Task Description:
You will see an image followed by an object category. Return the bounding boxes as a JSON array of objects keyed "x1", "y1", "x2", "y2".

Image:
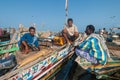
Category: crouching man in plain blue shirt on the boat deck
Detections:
[{"x1": 18, "y1": 27, "x2": 40, "y2": 54}]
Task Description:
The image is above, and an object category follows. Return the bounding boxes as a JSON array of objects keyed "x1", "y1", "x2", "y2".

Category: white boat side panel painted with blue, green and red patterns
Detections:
[{"x1": 8, "y1": 47, "x2": 71, "y2": 80}]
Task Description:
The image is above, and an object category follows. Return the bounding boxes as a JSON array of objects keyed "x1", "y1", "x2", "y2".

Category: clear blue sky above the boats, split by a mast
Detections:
[{"x1": 0, "y1": 0, "x2": 120, "y2": 32}]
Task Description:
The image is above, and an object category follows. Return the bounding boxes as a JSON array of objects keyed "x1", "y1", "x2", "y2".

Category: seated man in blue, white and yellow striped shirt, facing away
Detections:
[{"x1": 75, "y1": 25, "x2": 107, "y2": 65}]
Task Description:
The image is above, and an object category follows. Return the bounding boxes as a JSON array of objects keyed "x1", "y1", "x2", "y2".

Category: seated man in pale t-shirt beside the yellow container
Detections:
[{"x1": 63, "y1": 18, "x2": 79, "y2": 44}]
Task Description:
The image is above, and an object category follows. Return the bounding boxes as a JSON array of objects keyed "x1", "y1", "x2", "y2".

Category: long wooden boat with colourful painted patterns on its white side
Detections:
[{"x1": 0, "y1": 43, "x2": 73, "y2": 80}]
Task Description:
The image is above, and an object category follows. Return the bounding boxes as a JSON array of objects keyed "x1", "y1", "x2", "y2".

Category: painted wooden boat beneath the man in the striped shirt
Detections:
[{"x1": 75, "y1": 50, "x2": 120, "y2": 80}]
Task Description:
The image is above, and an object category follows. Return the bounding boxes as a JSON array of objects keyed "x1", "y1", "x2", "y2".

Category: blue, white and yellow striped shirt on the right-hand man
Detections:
[{"x1": 79, "y1": 37, "x2": 107, "y2": 64}]
